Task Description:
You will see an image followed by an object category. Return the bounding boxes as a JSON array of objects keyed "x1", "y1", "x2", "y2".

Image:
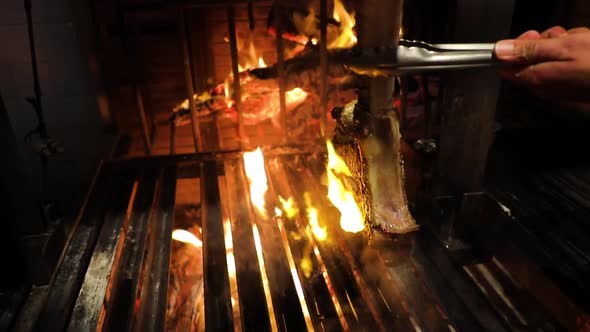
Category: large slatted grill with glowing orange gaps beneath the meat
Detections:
[{"x1": 11, "y1": 150, "x2": 580, "y2": 331}]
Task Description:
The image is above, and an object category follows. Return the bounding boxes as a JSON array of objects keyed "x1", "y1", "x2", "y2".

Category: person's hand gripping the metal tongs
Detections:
[{"x1": 495, "y1": 27, "x2": 590, "y2": 105}]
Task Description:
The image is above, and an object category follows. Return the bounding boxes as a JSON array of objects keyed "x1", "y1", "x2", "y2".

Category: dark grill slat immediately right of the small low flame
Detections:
[{"x1": 201, "y1": 161, "x2": 234, "y2": 331}]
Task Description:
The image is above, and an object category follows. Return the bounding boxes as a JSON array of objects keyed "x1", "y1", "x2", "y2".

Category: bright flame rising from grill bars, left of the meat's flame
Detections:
[{"x1": 243, "y1": 147, "x2": 268, "y2": 217}]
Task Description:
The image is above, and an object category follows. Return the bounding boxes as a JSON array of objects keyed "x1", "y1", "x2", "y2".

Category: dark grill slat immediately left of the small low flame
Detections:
[{"x1": 133, "y1": 166, "x2": 176, "y2": 331}]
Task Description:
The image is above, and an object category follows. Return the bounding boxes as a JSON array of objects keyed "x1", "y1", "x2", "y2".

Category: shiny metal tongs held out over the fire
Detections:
[{"x1": 353, "y1": 39, "x2": 500, "y2": 75}]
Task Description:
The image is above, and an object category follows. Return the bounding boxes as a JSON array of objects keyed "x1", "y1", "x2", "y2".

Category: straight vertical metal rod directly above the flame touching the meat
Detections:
[{"x1": 320, "y1": 0, "x2": 328, "y2": 137}]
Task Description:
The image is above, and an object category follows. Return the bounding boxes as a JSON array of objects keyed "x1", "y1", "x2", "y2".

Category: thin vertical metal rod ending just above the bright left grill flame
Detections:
[{"x1": 227, "y1": 5, "x2": 245, "y2": 141}]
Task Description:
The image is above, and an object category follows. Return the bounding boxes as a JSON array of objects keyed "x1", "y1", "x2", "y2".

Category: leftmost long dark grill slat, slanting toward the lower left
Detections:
[{"x1": 35, "y1": 167, "x2": 132, "y2": 331}]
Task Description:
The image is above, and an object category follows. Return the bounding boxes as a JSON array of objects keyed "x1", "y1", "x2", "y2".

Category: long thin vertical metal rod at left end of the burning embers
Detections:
[{"x1": 180, "y1": 11, "x2": 203, "y2": 152}]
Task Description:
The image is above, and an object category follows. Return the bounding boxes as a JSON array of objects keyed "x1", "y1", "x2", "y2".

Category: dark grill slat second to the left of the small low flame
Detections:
[{"x1": 97, "y1": 170, "x2": 159, "y2": 331}]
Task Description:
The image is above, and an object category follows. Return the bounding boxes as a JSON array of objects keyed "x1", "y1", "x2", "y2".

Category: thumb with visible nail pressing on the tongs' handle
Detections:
[{"x1": 494, "y1": 38, "x2": 565, "y2": 64}]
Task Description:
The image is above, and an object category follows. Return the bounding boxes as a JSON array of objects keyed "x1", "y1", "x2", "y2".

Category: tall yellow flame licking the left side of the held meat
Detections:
[{"x1": 326, "y1": 141, "x2": 365, "y2": 233}]
